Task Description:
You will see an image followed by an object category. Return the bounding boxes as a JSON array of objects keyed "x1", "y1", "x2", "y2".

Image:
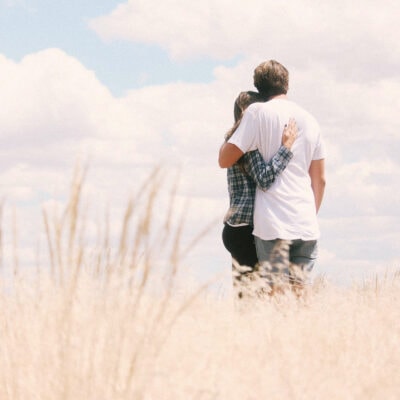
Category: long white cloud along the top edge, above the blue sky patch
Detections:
[{"x1": 90, "y1": 0, "x2": 400, "y2": 80}]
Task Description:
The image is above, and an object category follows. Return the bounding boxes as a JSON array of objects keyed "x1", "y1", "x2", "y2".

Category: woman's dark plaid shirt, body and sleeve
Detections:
[{"x1": 224, "y1": 146, "x2": 293, "y2": 225}]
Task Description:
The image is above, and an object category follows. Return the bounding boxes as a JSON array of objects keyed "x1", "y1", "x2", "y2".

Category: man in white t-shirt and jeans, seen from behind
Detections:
[{"x1": 219, "y1": 60, "x2": 325, "y2": 291}]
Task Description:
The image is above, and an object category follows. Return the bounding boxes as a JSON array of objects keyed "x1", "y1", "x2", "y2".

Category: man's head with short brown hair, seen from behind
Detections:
[{"x1": 254, "y1": 60, "x2": 289, "y2": 97}]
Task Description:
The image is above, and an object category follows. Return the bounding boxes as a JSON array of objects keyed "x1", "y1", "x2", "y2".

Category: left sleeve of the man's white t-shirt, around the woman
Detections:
[{"x1": 228, "y1": 106, "x2": 259, "y2": 153}]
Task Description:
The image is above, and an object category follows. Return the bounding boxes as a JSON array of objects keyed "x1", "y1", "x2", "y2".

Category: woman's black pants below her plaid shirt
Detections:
[{"x1": 222, "y1": 224, "x2": 258, "y2": 268}]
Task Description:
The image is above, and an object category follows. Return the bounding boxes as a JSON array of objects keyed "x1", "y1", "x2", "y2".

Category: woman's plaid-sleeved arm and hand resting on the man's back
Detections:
[{"x1": 245, "y1": 119, "x2": 298, "y2": 191}]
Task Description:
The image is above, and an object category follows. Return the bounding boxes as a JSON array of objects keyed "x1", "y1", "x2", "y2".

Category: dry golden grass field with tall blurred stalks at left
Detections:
[{"x1": 0, "y1": 171, "x2": 400, "y2": 400}]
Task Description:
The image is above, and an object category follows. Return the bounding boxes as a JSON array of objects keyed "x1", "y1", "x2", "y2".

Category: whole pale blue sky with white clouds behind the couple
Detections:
[{"x1": 0, "y1": 0, "x2": 400, "y2": 284}]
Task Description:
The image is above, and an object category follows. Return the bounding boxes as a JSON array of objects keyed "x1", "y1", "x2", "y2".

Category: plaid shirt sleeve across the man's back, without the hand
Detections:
[{"x1": 245, "y1": 146, "x2": 293, "y2": 191}]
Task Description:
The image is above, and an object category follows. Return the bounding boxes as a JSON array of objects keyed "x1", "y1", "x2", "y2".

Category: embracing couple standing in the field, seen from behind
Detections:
[{"x1": 219, "y1": 60, "x2": 325, "y2": 297}]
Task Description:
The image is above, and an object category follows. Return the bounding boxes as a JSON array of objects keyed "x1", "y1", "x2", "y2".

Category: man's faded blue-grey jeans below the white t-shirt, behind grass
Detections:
[{"x1": 255, "y1": 237, "x2": 318, "y2": 287}]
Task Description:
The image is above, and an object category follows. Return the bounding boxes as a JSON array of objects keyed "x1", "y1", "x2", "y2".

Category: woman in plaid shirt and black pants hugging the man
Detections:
[{"x1": 222, "y1": 91, "x2": 297, "y2": 297}]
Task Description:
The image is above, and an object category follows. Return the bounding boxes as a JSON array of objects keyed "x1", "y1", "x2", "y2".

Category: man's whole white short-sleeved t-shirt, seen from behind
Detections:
[{"x1": 229, "y1": 98, "x2": 325, "y2": 240}]
